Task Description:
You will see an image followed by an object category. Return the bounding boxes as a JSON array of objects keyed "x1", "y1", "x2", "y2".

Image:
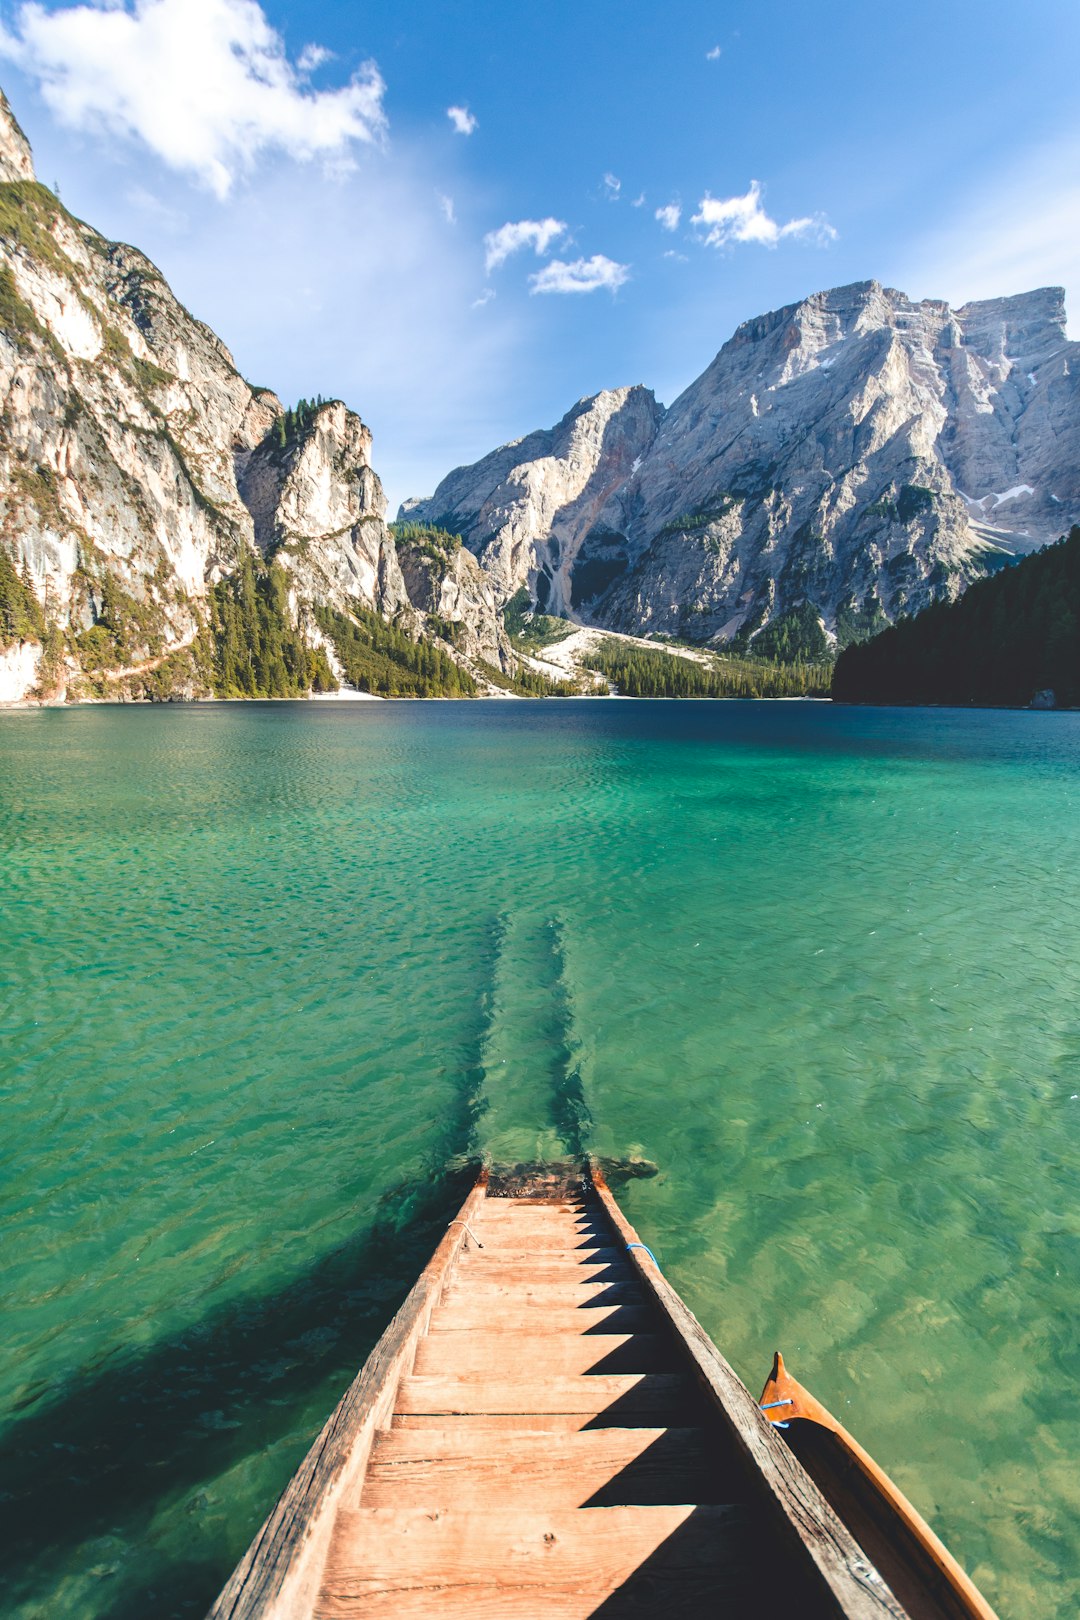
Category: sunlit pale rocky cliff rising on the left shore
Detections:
[{"x1": 0, "y1": 85, "x2": 500, "y2": 701}]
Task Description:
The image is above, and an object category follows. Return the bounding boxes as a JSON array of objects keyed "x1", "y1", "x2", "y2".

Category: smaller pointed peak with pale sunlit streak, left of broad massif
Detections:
[{"x1": 402, "y1": 387, "x2": 664, "y2": 612}]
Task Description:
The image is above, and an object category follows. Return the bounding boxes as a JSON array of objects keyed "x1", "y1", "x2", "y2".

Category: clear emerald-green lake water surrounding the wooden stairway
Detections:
[{"x1": 0, "y1": 701, "x2": 1080, "y2": 1620}]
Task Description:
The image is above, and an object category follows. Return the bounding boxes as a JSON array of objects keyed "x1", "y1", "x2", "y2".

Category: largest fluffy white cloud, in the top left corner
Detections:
[{"x1": 0, "y1": 0, "x2": 387, "y2": 198}]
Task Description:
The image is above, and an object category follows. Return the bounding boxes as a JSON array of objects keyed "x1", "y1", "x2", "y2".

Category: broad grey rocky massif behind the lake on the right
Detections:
[{"x1": 408, "y1": 282, "x2": 1080, "y2": 642}]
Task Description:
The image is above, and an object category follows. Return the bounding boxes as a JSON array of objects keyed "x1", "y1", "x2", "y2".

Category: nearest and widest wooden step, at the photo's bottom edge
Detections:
[{"x1": 316, "y1": 1507, "x2": 764, "y2": 1620}]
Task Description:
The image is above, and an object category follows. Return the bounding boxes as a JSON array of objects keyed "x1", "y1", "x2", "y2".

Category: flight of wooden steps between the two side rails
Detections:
[{"x1": 316, "y1": 1187, "x2": 824, "y2": 1620}]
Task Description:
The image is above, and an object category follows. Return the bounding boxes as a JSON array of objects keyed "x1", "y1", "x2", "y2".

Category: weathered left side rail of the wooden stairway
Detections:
[{"x1": 207, "y1": 1171, "x2": 487, "y2": 1620}]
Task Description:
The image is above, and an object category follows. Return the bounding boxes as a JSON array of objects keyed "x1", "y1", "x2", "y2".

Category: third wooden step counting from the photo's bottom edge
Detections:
[{"x1": 395, "y1": 1372, "x2": 690, "y2": 1427}]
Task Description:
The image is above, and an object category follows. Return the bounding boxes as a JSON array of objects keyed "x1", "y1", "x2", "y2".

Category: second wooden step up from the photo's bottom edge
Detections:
[{"x1": 358, "y1": 1424, "x2": 732, "y2": 1511}]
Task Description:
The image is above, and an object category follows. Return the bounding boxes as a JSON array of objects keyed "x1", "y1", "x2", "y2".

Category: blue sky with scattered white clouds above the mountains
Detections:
[{"x1": 0, "y1": 0, "x2": 1080, "y2": 507}]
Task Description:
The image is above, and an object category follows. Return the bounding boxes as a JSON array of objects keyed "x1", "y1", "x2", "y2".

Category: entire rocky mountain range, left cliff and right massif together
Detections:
[{"x1": 0, "y1": 78, "x2": 1080, "y2": 701}]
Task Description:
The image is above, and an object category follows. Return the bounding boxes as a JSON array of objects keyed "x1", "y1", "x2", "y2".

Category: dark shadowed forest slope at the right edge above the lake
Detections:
[{"x1": 832, "y1": 528, "x2": 1080, "y2": 708}]
